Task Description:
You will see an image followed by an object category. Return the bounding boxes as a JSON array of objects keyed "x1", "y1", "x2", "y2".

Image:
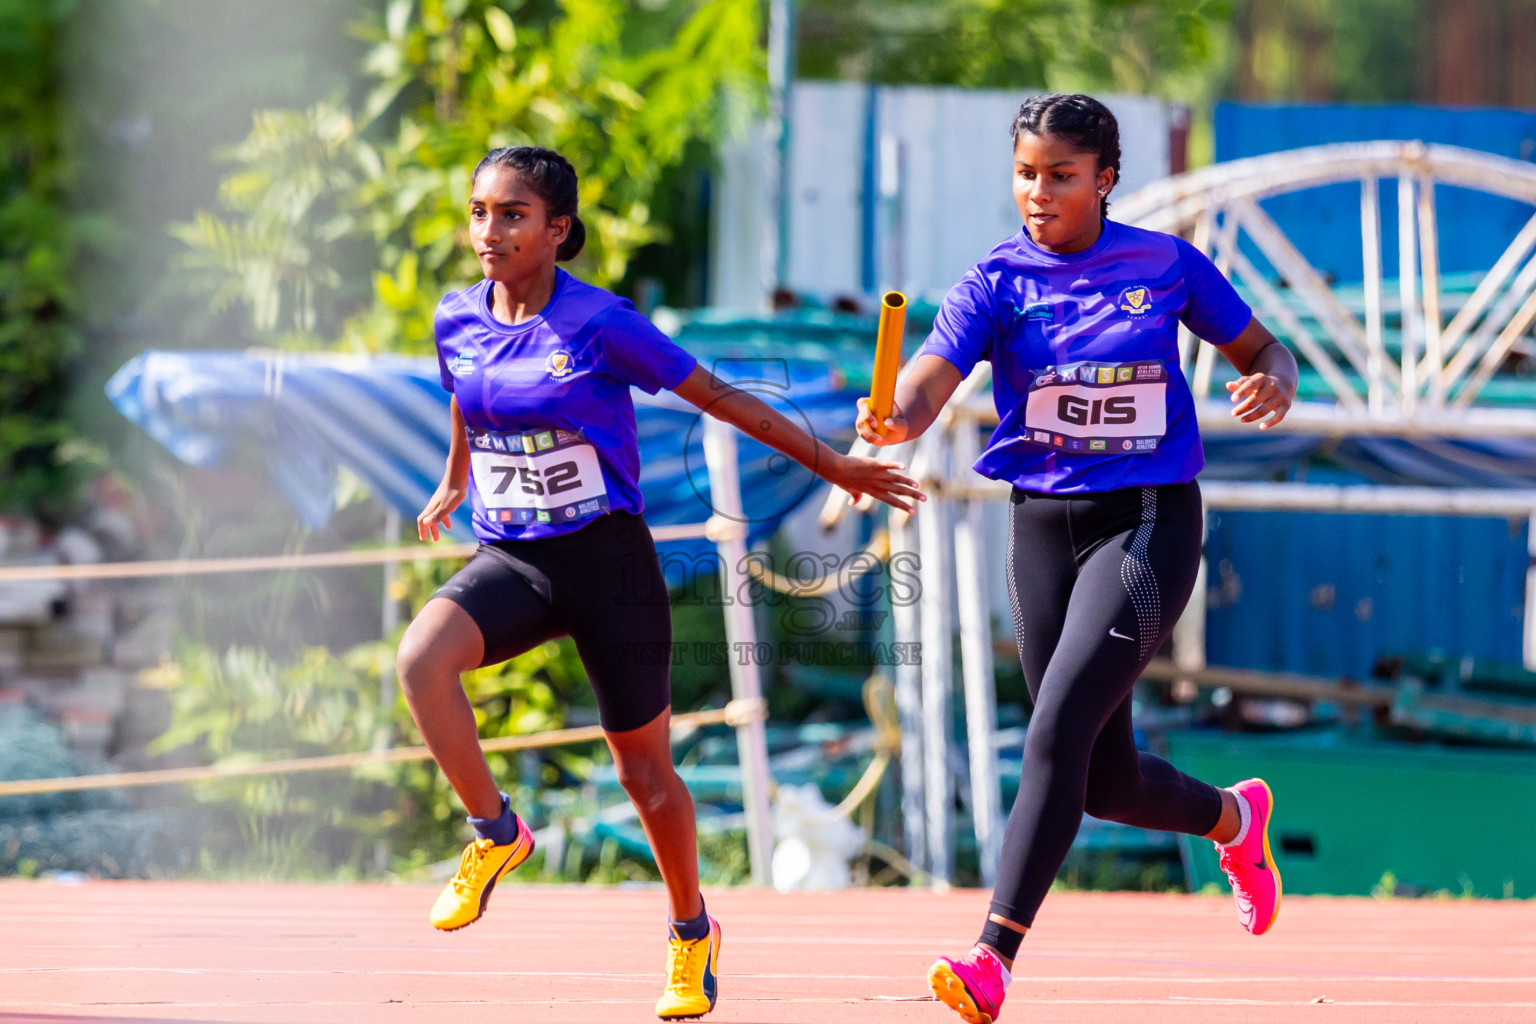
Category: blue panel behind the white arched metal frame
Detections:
[{"x1": 1215, "y1": 103, "x2": 1536, "y2": 281}]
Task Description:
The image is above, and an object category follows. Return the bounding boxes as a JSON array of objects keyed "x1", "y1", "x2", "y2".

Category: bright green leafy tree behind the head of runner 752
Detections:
[{"x1": 178, "y1": 0, "x2": 762, "y2": 352}]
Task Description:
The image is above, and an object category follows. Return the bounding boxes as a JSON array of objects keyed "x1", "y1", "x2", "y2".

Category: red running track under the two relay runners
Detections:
[{"x1": 0, "y1": 881, "x2": 1536, "y2": 1024}]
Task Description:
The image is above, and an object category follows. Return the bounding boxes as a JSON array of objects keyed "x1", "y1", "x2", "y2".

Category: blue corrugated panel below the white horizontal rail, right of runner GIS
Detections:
[{"x1": 1206, "y1": 511, "x2": 1527, "y2": 679}]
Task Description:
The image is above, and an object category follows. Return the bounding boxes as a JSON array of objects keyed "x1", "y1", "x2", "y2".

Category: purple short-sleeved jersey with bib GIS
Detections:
[{"x1": 919, "y1": 221, "x2": 1253, "y2": 494}]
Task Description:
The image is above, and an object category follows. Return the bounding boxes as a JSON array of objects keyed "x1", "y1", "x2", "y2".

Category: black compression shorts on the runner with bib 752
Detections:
[{"x1": 433, "y1": 511, "x2": 671, "y2": 732}]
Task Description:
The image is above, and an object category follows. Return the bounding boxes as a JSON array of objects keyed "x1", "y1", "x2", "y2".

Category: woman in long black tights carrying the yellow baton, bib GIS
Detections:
[{"x1": 857, "y1": 95, "x2": 1296, "y2": 1024}]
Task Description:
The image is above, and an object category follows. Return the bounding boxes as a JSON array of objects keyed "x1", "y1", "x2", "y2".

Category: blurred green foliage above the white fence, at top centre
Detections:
[{"x1": 799, "y1": 0, "x2": 1230, "y2": 97}]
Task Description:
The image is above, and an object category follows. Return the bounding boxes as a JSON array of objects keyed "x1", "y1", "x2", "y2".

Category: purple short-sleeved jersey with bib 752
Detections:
[{"x1": 435, "y1": 270, "x2": 697, "y2": 542}]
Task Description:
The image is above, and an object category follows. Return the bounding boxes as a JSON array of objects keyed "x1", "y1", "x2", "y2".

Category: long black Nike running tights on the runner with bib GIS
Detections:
[{"x1": 992, "y1": 482, "x2": 1221, "y2": 926}]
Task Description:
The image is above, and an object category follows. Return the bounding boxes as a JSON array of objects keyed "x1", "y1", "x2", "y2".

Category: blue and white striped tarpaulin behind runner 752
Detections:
[{"x1": 106, "y1": 350, "x2": 854, "y2": 536}]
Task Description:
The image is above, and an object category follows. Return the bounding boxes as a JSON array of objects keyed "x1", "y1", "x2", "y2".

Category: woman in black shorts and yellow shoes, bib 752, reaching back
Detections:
[{"x1": 396, "y1": 146, "x2": 922, "y2": 1019}]
